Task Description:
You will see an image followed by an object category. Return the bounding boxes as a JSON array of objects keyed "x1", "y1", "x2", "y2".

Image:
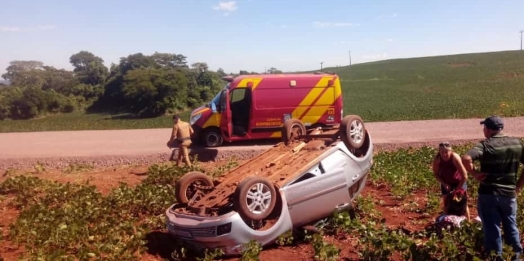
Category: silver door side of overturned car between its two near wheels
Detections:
[{"x1": 283, "y1": 150, "x2": 350, "y2": 226}]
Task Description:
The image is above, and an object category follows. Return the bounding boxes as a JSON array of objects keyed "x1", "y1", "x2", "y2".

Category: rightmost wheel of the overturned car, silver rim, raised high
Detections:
[{"x1": 340, "y1": 115, "x2": 366, "y2": 149}]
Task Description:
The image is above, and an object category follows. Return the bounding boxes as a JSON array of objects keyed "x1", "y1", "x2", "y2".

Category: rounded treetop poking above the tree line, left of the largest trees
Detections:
[{"x1": 69, "y1": 51, "x2": 109, "y2": 85}]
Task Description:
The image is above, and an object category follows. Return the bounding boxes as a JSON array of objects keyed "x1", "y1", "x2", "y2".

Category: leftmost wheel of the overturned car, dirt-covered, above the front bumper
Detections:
[{"x1": 175, "y1": 171, "x2": 213, "y2": 204}]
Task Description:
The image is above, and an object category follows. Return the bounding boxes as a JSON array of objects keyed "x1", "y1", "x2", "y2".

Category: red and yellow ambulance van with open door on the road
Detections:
[{"x1": 189, "y1": 73, "x2": 344, "y2": 147}]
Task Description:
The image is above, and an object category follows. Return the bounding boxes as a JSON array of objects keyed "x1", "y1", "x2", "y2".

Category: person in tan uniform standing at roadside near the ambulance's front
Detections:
[{"x1": 167, "y1": 115, "x2": 193, "y2": 167}]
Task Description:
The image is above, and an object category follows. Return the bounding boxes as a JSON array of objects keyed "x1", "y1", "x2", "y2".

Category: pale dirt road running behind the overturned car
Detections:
[{"x1": 0, "y1": 117, "x2": 524, "y2": 170}]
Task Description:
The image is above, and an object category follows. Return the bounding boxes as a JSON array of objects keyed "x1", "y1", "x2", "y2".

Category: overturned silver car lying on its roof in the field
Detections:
[{"x1": 166, "y1": 115, "x2": 373, "y2": 255}]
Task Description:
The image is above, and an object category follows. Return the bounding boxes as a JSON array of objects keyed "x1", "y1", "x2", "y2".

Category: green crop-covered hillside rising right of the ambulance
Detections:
[{"x1": 324, "y1": 51, "x2": 524, "y2": 121}]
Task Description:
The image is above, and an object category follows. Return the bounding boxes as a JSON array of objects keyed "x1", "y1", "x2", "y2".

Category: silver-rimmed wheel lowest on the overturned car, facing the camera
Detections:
[{"x1": 233, "y1": 176, "x2": 277, "y2": 221}]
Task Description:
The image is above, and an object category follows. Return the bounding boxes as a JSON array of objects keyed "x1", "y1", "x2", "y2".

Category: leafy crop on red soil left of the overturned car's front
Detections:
[{"x1": 0, "y1": 164, "x2": 183, "y2": 260}]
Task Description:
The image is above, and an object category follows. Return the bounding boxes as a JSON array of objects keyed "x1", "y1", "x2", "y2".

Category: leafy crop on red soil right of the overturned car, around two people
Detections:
[{"x1": 312, "y1": 141, "x2": 524, "y2": 260}]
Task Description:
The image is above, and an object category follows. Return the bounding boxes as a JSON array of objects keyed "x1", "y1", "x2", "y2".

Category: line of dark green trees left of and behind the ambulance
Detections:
[{"x1": 0, "y1": 51, "x2": 281, "y2": 120}]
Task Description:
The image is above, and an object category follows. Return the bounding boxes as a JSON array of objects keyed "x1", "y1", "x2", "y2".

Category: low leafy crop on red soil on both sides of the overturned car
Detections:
[{"x1": 0, "y1": 144, "x2": 524, "y2": 261}]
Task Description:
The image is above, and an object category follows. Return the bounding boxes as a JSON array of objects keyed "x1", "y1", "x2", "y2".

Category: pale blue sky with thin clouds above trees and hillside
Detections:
[{"x1": 0, "y1": 0, "x2": 524, "y2": 74}]
